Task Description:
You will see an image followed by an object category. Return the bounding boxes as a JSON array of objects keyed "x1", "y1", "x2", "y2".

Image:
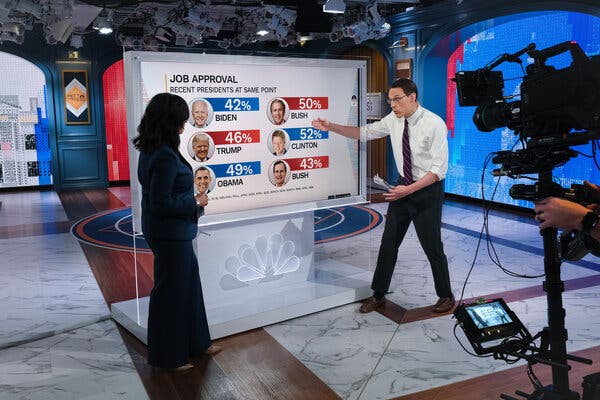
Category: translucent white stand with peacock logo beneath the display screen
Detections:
[{"x1": 111, "y1": 211, "x2": 373, "y2": 343}]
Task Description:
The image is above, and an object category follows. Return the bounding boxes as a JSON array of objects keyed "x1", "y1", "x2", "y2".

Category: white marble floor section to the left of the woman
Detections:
[{"x1": 0, "y1": 191, "x2": 146, "y2": 400}]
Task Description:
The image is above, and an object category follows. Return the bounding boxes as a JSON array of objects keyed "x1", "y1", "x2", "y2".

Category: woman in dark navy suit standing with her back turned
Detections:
[{"x1": 133, "y1": 93, "x2": 220, "y2": 371}]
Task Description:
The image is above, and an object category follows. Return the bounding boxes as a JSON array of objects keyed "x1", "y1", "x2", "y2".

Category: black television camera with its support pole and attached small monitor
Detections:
[{"x1": 452, "y1": 41, "x2": 600, "y2": 400}]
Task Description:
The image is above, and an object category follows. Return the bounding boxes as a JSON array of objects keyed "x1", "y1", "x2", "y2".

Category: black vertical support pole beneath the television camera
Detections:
[{"x1": 500, "y1": 170, "x2": 592, "y2": 400}]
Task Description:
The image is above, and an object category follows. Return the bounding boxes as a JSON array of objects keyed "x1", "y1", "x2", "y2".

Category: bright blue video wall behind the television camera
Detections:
[{"x1": 446, "y1": 12, "x2": 600, "y2": 207}]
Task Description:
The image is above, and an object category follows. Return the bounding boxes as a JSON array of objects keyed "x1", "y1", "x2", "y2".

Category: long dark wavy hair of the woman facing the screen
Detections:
[{"x1": 133, "y1": 93, "x2": 190, "y2": 152}]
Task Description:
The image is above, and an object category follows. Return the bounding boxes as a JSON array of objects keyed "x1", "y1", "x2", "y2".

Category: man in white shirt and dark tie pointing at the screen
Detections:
[{"x1": 312, "y1": 79, "x2": 455, "y2": 313}]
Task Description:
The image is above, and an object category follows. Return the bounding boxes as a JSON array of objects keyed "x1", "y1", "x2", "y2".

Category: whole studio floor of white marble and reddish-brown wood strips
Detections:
[{"x1": 0, "y1": 187, "x2": 600, "y2": 400}]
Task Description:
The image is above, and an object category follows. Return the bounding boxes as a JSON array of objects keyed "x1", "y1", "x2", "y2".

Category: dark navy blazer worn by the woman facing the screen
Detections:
[{"x1": 138, "y1": 145, "x2": 204, "y2": 240}]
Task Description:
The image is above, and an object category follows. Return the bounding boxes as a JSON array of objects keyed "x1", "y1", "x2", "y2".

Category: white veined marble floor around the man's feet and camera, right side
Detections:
[{"x1": 266, "y1": 203, "x2": 600, "y2": 400}]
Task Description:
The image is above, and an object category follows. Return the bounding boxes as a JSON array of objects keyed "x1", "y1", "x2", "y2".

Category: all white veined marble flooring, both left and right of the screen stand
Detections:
[{"x1": 0, "y1": 189, "x2": 600, "y2": 400}]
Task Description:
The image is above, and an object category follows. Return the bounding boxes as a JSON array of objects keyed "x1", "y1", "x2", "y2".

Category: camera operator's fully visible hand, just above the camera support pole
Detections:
[{"x1": 533, "y1": 197, "x2": 590, "y2": 230}]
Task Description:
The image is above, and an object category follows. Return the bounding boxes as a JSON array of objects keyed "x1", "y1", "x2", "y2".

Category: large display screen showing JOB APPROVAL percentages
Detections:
[{"x1": 125, "y1": 52, "x2": 365, "y2": 228}]
